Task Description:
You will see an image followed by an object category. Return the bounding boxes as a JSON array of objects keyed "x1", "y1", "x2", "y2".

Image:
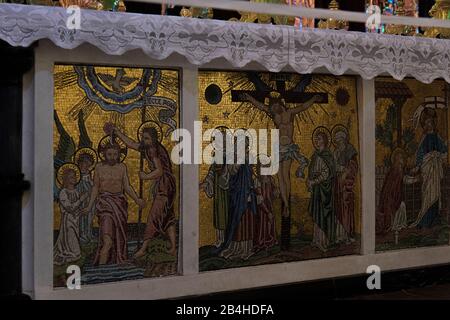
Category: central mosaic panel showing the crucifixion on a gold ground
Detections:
[{"x1": 198, "y1": 70, "x2": 361, "y2": 271}]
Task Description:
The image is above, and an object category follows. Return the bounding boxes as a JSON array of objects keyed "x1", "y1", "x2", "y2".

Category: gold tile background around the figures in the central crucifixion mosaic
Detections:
[{"x1": 198, "y1": 71, "x2": 361, "y2": 247}]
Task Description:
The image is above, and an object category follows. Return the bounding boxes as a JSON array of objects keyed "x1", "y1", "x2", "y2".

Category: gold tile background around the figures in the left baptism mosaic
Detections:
[{"x1": 53, "y1": 65, "x2": 180, "y2": 229}]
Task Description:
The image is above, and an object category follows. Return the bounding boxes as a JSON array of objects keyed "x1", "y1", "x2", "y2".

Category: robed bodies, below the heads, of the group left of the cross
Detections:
[{"x1": 200, "y1": 149, "x2": 278, "y2": 259}]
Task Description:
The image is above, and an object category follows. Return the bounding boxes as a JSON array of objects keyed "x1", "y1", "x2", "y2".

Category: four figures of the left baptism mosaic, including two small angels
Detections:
[{"x1": 54, "y1": 123, "x2": 177, "y2": 265}]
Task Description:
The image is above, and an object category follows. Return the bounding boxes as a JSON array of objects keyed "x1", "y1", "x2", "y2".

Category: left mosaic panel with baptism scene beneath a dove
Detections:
[{"x1": 53, "y1": 65, "x2": 180, "y2": 287}]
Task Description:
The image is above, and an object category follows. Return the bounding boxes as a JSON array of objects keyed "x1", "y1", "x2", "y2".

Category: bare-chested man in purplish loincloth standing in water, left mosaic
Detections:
[{"x1": 85, "y1": 142, "x2": 145, "y2": 265}]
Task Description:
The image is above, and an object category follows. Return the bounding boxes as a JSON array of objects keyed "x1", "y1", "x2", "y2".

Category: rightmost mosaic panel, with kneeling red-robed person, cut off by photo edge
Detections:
[{"x1": 375, "y1": 77, "x2": 450, "y2": 251}]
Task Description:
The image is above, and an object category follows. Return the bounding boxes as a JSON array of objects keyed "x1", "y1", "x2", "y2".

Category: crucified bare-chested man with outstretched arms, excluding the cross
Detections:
[{"x1": 242, "y1": 93, "x2": 322, "y2": 217}]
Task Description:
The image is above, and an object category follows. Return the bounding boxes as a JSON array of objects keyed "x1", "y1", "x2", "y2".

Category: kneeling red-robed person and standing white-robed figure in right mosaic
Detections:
[{"x1": 376, "y1": 108, "x2": 448, "y2": 234}]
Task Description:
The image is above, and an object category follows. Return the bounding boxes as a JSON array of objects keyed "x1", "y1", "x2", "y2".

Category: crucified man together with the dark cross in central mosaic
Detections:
[{"x1": 233, "y1": 77, "x2": 328, "y2": 250}]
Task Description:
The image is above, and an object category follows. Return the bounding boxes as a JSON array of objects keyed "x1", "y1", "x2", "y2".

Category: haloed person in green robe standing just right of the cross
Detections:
[{"x1": 307, "y1": 127, "x2": 336, "y2": 252}]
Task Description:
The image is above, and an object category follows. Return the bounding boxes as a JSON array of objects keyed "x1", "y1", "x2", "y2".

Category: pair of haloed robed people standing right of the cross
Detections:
[{"x1": 306, "y1": 125, "x2": 358, "y2": 252}]
